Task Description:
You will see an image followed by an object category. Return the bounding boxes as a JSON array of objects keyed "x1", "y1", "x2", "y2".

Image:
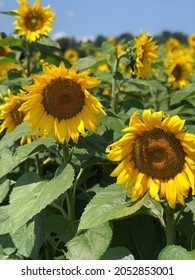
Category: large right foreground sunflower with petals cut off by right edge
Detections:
[{"x1": 106, "y1": 109, "x2": 195, "y2": 208}]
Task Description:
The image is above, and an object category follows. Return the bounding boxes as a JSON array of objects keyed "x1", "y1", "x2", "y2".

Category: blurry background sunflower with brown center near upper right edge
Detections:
[{"x1": 164, "y1": 48, "x2": 193, "y2": 89}]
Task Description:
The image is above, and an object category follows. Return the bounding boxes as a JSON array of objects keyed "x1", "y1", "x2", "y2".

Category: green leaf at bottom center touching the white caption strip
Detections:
[{"x1": 66, "y1": 223, "x2": 112, "y2": 260}]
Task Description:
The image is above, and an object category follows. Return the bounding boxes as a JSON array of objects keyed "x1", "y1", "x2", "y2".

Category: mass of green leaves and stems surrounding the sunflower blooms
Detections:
[{"x1": 0, "y1": 3, "x2": 195, "y2": 260}]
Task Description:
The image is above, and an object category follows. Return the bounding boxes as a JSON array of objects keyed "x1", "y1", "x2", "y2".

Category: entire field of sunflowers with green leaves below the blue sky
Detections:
[{"x1": 0, "y1": 0, "x2": 195, "y2": 260}]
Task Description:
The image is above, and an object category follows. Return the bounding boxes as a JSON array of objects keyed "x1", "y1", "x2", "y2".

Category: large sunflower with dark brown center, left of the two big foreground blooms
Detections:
[{"x1": 20, "y1": 62, "x2": 106, "y2": 143}]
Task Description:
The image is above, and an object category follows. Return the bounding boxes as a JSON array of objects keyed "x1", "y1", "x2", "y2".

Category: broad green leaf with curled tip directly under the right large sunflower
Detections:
[{"x1": 79, "y1": 184, "x2": 148, "y2": 230}]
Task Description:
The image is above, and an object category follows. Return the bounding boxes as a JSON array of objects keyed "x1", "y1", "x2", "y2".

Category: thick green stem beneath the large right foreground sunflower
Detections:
[{"x1": 165, "y1": 205, "x2": 175, "y2": 246}]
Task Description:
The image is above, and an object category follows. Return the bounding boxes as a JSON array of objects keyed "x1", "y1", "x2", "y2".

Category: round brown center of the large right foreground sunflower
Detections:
[{"x1": 132, "y1": 128, "x2": 185, "y2": 179}]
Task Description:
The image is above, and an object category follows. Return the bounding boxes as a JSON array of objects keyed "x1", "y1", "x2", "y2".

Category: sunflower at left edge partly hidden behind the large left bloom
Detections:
[{"x1": 0, "y1": 90, "x2": 37, "y2": 145}]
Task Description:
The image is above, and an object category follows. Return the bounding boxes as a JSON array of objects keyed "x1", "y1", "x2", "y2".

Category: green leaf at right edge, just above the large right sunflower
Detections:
[{"x1": 171, "y1": 83, "x2": 195, "y2": 105}]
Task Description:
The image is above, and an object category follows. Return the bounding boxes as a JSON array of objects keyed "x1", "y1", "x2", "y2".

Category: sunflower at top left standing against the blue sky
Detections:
[{"x1": 14, "y1": 0, "x2": 54, "y2": 43}]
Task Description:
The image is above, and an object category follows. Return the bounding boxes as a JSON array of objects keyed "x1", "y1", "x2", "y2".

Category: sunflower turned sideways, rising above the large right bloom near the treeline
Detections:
[{"x1": 134, "y1": 33, "x2": 158, "y2": 79}]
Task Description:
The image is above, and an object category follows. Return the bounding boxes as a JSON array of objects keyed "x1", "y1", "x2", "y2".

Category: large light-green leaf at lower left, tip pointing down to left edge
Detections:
[{"x1": 0, "y1": 165, "x2": 74, "y2": 234}]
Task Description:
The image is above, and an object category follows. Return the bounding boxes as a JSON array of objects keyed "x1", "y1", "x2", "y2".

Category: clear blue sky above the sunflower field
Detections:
[{"x1": 0, "y1": 0, "x2": 195, "y2": 39}]
